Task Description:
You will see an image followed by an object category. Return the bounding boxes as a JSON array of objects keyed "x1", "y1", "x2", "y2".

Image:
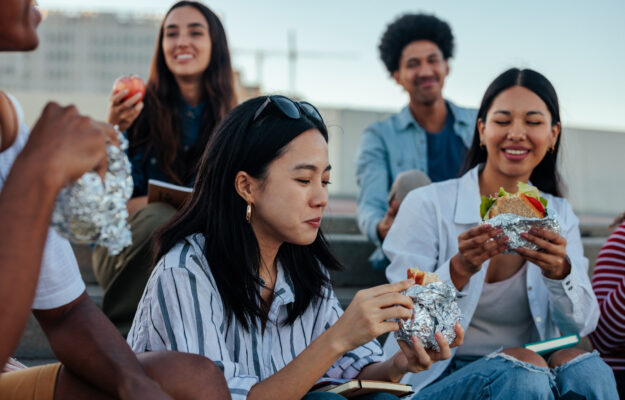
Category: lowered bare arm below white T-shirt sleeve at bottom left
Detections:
[{"x1": 33, "y1": 292, "x2": 170, "y2": 399}]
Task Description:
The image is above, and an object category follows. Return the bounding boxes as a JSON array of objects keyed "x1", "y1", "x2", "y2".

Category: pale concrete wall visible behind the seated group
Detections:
[{"x1": 7, "y1": 91, "x2": 625, "y2": 216}]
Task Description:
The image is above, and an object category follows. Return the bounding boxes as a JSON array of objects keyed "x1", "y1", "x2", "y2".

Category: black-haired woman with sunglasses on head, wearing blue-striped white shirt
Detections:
[{"x1": 128, "y1": 96, "x2": 463, "y2": 399}]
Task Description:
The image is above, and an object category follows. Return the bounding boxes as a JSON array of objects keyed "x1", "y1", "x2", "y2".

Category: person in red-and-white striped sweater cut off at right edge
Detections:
[{"x1": 590, "y1": 213, "x2": 625, "y2": 399}]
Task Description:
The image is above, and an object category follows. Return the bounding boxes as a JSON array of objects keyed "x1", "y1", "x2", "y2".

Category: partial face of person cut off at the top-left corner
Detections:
[{"x1": 0, "y1": 0, "x2": 41, "y2": 51}]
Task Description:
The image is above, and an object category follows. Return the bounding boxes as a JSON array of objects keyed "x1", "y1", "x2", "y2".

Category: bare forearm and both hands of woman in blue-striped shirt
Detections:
[{"x1": 248, "y1": 281, "x2": 448, "y2": 400}]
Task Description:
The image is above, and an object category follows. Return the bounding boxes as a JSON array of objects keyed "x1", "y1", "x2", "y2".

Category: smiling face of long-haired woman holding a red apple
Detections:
[{"x1": 162, "y1": 6, "x2": 212, "y2": 79}]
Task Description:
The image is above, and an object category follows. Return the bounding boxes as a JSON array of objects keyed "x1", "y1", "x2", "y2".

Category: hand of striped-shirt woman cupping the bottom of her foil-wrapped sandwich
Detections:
[{"x1": 393, "y1": 324, "x2": 464, "y2": 375}]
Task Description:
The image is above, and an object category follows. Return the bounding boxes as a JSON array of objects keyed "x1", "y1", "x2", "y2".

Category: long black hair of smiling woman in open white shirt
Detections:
[{"x1": 460, "y1": 68, "x2": 562, "y2": 196}]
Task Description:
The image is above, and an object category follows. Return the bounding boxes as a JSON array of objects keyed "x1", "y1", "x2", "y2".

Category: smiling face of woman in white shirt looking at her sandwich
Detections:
[{"x1": 477, "y1": 86, "x2": 560, "y2": 182}]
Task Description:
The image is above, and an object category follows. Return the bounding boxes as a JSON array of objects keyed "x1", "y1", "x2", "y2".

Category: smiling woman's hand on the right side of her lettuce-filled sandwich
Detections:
[{"x1": 515, "y1": 228, "x2": 571, "y2": 280}]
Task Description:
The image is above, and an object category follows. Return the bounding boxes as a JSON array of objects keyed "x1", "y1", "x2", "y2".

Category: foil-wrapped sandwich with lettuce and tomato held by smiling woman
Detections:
[{"x1": 480, "y1": 182, "x2": 560, "y2": 253}]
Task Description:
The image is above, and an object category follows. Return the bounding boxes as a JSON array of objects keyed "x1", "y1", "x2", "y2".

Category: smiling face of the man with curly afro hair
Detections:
[{"x1": 393, "y1": 40, "x2": 449, "y2": 105}]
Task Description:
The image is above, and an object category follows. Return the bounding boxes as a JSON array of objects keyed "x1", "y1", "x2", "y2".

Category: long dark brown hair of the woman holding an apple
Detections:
[{"x1": 128, "y1": 1, "x2": 236, "y2": 185}]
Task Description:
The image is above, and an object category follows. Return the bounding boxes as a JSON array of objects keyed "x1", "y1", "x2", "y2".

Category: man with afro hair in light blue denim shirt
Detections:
[{"x1": 356, "y1": 14, "x2": 476, "y2": 269}]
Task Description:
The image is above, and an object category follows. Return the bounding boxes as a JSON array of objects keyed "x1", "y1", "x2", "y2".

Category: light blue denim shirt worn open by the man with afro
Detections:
[{"x1": 356, "y1": 100, "x2": 477, "y2": 269}]
